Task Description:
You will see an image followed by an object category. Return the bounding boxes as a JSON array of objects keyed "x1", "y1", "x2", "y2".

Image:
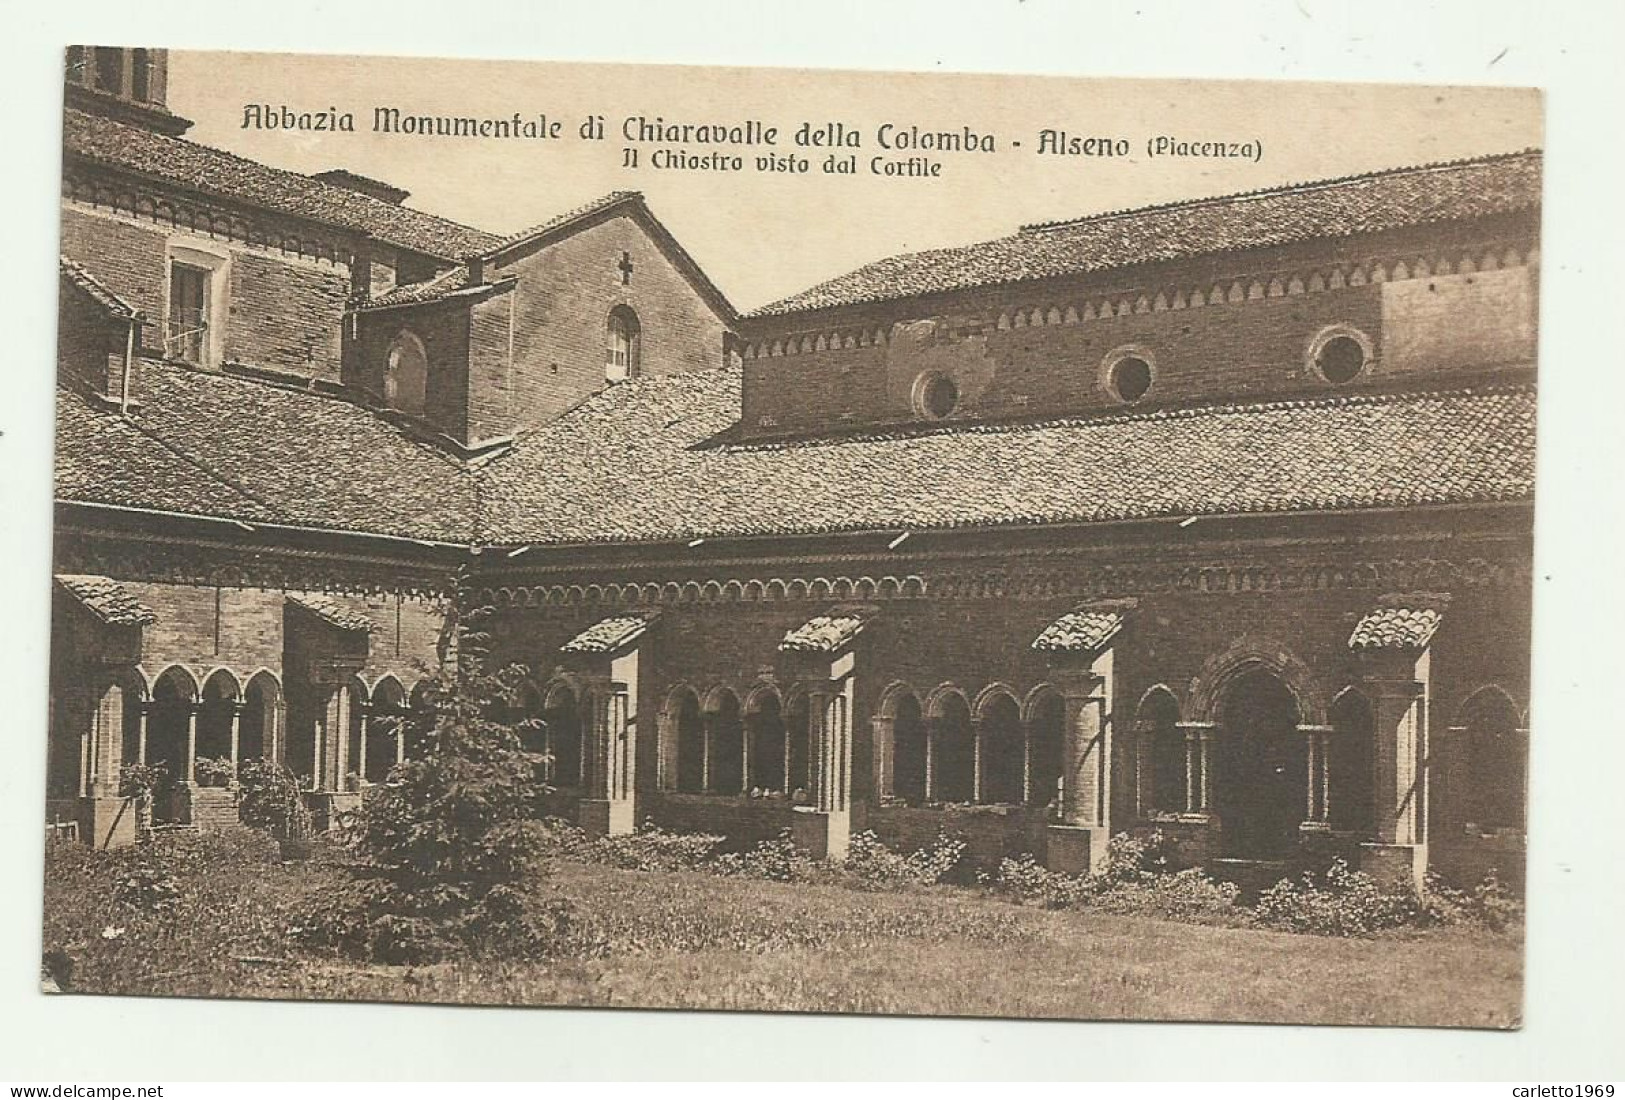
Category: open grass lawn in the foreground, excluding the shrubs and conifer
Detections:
[{"x1": 46, "y1": 831, "x2": 1523, "y2": 1027}]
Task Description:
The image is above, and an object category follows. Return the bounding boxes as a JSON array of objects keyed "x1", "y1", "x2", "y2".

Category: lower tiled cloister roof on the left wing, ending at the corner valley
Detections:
[{"x1": 57, "y1": 359, "x2": 475, "y2": 541}]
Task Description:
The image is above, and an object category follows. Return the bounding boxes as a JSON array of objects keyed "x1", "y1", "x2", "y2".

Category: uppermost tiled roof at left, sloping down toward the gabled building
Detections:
[{"x1": 62, "y1": 109, "x2": 499, "y2": 260}]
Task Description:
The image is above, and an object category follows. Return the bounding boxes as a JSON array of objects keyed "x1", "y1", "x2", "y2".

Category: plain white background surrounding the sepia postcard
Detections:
[{"x1": 0, "y1": 0, "x2": 1625, "y2": 1078}]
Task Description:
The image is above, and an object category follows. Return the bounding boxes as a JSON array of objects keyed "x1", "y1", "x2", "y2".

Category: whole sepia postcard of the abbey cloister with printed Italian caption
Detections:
[{"x1": 34, "y1": 44, "x2": 1534, "y2": 1029}]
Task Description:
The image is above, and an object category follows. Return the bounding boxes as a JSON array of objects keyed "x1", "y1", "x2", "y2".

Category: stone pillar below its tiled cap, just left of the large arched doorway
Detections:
[{"x1": 1045, "y1": 652, "x2": 1112, "y2": 874}]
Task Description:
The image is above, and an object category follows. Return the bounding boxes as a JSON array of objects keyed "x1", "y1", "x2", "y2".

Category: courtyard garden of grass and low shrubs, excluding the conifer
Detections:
[{"x1": 44, "y1": 824, "x2": 1523, "y2": 1027}]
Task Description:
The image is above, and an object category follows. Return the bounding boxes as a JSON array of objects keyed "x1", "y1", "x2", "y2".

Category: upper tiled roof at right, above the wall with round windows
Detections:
[{"x1": 752, "y1": 151, "x2": 1542, "y2": 317}]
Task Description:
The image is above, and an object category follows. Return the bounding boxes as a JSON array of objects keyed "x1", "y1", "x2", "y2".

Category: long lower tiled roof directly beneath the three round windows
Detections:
[{"x1": 481, "y1": 369, "x2": 1536, "y2": 543}]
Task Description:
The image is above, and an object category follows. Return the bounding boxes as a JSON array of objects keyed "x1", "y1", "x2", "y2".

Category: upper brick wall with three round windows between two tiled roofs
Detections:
[{"x1": 743, "y1": 214, "x2": 1537, "y2": 434}]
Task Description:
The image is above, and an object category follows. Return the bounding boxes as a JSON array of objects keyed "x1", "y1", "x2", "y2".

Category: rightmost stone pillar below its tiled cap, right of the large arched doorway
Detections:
[{"x1": 1360, "y1": 652, "x2": 1428, "y2": 889}]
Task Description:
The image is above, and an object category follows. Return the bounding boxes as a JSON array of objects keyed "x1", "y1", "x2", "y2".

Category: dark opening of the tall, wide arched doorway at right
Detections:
[{"x1": 1214, "y1": 668, "x2": 1308, "y2": 860}]
